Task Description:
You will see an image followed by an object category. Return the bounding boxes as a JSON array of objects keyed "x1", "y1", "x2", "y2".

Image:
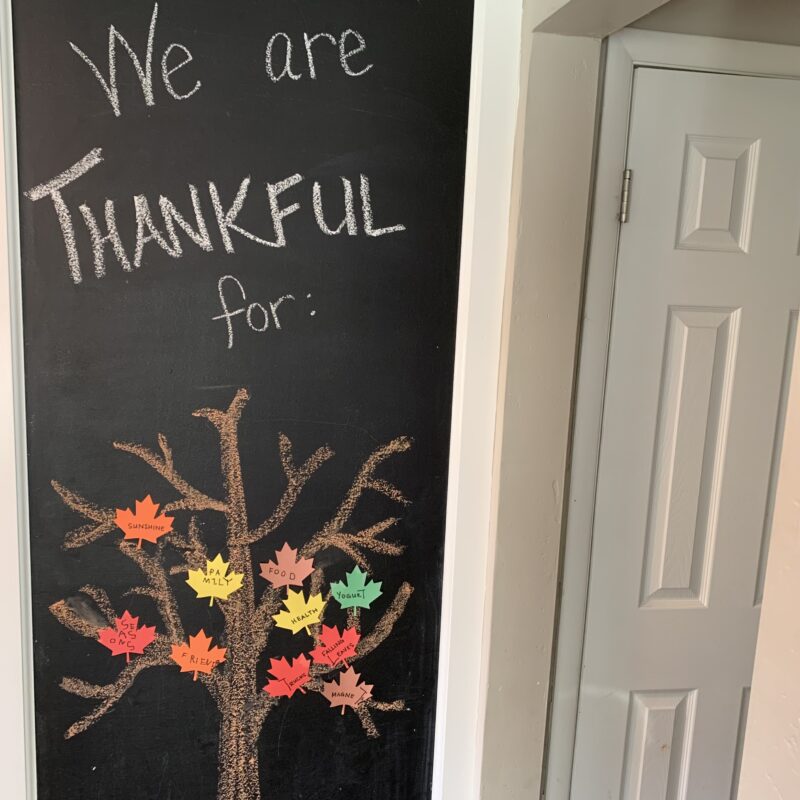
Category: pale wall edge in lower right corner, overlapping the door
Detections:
[{"x1": 738, "y1": 336, "x2": 800, "y2": 800}]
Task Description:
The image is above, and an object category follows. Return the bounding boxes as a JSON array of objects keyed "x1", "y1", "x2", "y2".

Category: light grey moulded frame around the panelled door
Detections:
[{"x1": 544, "y1": 28, "x2": 800, "y2": 800}]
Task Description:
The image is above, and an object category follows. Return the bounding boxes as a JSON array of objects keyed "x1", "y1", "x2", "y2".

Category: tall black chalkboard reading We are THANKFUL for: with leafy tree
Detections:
[{"x1": 6, "y1": 0, "x2": 472, "y2": 800}]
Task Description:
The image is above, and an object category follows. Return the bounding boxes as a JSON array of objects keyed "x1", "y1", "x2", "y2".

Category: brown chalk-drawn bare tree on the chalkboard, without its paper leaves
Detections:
[{"x1": 50, "y1": 389, "x2": 413, "y2": 800}]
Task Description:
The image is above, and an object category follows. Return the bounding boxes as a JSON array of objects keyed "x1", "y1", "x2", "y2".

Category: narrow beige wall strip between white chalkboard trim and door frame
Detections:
[{"x1": 481, "y1": 29, "x2": 601, "y2": 800}]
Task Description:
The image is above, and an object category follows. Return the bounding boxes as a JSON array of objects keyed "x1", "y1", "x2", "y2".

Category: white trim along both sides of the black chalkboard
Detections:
[{"x1": 0, "y1": 0, "x2": 522, "y2": 800}]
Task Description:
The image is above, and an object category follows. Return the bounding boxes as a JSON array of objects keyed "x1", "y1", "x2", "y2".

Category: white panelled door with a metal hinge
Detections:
[{"x1": 571, "y1": 68, "x2": 800, "y2": 800}]
